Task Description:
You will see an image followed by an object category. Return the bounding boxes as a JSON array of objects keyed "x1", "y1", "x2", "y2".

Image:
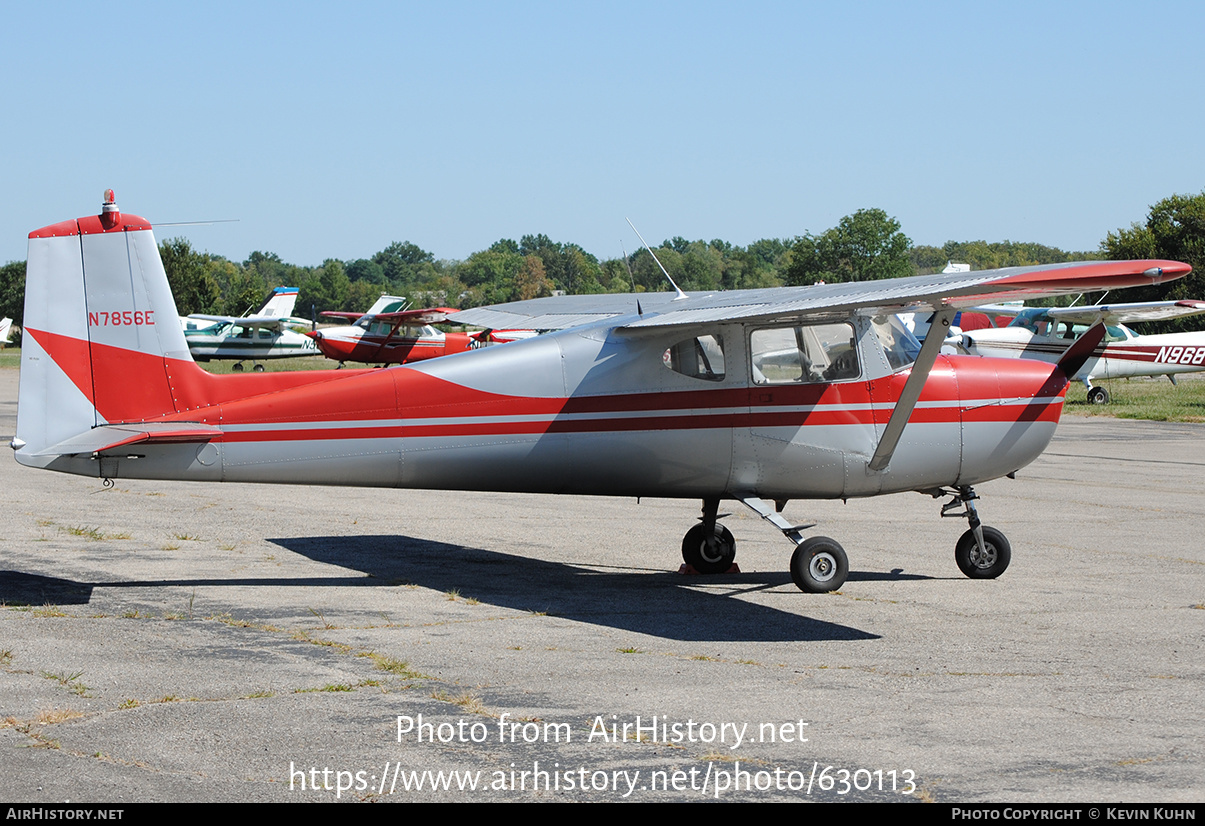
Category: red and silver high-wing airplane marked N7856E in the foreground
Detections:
[{"x1": 12, "y1": 195, "x2": 1191, "y2": 592}]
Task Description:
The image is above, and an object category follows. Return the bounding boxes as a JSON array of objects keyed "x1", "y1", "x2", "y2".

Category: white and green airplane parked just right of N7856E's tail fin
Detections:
[{"x1": 180, "y1": 287, "x2": 319, "y2": 373}]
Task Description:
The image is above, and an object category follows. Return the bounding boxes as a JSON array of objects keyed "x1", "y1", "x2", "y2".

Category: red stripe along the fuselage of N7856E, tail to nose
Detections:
[{"x1": 30, "y1": 330, "x2": 1066, "y2": 441}]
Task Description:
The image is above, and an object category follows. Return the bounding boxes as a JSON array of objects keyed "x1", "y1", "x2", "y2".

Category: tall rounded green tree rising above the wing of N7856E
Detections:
[{"x1": 786, "y1": 209, "x2": 915, "y2": 286}]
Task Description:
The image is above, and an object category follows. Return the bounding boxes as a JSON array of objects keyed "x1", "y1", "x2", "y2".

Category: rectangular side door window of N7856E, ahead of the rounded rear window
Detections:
[{"x1": 750, "y1": 323, "x2": 862, "y2": 385}]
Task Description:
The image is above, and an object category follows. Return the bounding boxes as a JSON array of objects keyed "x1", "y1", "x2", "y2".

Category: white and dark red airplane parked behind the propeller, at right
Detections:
[{"x1": 946, "y1": 301, "x2": 1205, "y2": 404}]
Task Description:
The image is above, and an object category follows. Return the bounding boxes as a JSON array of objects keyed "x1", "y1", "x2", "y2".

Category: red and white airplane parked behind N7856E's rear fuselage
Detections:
[{"x1": 306, "y1": 295, "x2": 535, "y2": 367}]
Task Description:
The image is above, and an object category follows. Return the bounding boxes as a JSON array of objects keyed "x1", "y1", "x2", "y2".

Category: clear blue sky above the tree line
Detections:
[{"x1": 0, "y1": 0, "x2": 1205, "y2": 265}]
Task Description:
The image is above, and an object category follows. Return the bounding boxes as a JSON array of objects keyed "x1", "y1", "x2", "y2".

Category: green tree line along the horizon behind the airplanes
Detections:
[{"x1": 0, "y1": 192, "x2": 1205, "y2": 335}]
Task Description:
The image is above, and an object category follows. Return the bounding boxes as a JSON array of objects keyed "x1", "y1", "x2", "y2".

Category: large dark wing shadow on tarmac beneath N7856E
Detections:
[{"x1": 268, "y1": 535, "x2": 878, "y2": 642}]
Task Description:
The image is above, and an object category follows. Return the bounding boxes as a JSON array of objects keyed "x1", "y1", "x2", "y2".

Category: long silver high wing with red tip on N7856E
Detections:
[{"x1": 448, "y1": 260, "x2": 1192, "y2": 330}]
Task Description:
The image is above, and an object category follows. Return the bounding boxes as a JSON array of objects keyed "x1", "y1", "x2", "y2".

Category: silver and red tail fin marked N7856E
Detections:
[{"x1": 13, "y1": 189, "x2": 200, "y2": 464}]
